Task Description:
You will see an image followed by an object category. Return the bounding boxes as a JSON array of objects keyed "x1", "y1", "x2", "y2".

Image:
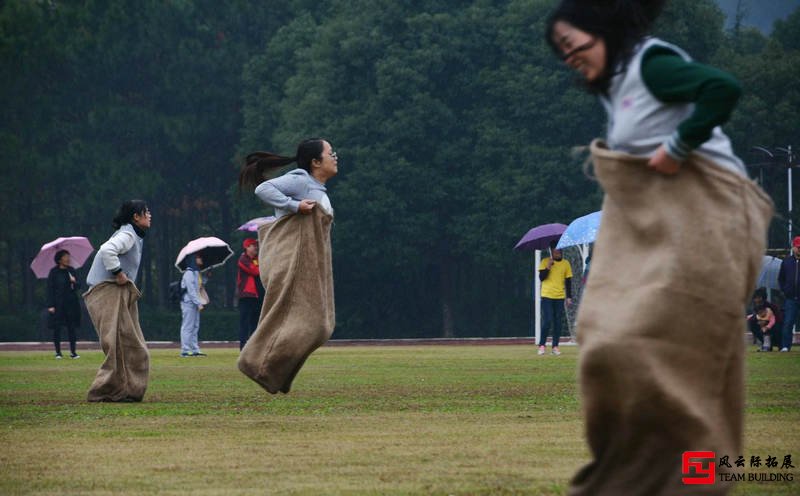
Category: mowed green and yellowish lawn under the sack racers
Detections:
[{"x1": 0, "y1": 346, "x2": 800, "y2": 495}]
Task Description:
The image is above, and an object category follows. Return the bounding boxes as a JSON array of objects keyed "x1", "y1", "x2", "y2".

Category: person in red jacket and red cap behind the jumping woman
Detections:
[{"x1": 236, "y1": 238, "x2": 264, "y2": 350}]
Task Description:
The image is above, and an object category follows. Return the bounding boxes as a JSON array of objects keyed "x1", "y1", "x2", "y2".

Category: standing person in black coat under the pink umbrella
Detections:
[{"x1": 47, "y1": 250, "x2": 81, "y2": 360}]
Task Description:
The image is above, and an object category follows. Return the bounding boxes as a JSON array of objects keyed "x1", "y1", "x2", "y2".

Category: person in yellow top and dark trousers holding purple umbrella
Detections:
[{"x1": 538, "y1": 243, "x2": 572, "y2": 355}]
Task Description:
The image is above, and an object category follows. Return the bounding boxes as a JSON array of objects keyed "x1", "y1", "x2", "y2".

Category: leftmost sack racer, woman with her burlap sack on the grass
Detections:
[{"x1": 83, "y1": 200, "x2": 151, "y2": 402}]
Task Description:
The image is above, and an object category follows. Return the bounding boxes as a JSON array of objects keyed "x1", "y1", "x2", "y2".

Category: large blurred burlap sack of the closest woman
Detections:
[{"x1": 569, "y1": 141, "x2": 773, "y2": 496}]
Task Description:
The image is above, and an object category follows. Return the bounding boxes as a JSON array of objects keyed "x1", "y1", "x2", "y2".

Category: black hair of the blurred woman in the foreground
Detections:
[{"x1": 545, "y1": 0, "x2": 666, "y2": 93}]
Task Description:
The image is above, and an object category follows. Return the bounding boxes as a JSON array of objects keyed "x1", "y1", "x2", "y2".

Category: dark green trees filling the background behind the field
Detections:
[{"x1": 0, "y1": 0, "x2": 800, "y2": 337}]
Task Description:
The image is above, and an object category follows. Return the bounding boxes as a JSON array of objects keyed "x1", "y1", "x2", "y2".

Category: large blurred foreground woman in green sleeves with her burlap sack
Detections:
[{"x1": 546, "y1": 0, "x2": 772, "y2": 496}]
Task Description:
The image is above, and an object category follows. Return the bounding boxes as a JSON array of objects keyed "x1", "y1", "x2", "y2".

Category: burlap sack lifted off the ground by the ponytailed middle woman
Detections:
[{"x1": 239, "y1": 203, "x2": 336, "y2": 394}]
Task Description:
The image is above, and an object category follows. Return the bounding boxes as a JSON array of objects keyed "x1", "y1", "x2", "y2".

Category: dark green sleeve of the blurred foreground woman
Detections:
[{"x1": 642, "y1": 46, "x2": 742, "y2": 160}]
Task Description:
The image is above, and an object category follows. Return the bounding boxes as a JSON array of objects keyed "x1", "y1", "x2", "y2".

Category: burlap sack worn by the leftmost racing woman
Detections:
[{"x1": 83, "y1": 282, "x2": 150, "y2": 401}]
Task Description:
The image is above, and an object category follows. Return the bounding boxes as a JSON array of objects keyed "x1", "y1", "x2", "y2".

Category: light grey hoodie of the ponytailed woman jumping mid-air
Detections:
[{"x1": 256, "y1": 169, "x2": 333, "y2": 218}]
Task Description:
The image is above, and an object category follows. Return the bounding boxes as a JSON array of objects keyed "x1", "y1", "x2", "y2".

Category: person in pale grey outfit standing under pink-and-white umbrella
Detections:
[{"x1": 181, "y1": 254, "x2": 209, "y2": 358}]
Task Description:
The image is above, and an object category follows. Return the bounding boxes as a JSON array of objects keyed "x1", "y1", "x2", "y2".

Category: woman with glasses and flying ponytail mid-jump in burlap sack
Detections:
[{"x1": 239, "y1": 138, "x2": 338, "y2": 394}]
